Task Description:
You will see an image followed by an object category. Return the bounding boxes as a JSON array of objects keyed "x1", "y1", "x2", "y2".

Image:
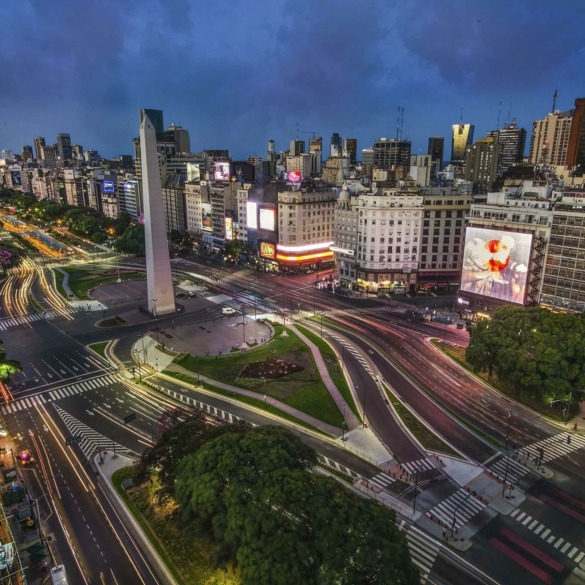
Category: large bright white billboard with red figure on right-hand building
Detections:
[{"x1": 460, "y1": 227, "x2": 532, "y2": 304}]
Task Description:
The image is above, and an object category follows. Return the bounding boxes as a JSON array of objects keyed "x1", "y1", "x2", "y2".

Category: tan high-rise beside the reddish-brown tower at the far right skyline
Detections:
[{"x1": 529, "y1": 110, "x2": 573, "y2": 167}]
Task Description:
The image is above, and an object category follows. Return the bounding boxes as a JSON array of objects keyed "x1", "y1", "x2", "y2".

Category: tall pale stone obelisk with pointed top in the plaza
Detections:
[{"x1": 140, "y1": 110, "x2": 175, "y2": 317}]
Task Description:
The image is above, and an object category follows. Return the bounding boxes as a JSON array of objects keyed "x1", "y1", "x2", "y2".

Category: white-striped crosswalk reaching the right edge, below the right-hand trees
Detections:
[{"x1": 488, "y1": 433, "x2": 585, "y2": 484}]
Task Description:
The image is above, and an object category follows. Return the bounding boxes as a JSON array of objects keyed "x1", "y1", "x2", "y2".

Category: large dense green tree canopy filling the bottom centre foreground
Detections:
[{"x1": 176, "y1": 426, "x2": 419, "y2": 585}]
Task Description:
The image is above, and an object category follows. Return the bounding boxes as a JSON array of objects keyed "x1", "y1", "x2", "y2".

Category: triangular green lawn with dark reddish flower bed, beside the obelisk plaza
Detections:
[{"x1": 168, "y1": 325, "x2": 343, "y2": 427}]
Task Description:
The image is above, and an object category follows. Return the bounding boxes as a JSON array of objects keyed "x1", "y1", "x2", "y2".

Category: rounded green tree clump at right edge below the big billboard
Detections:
[{"x1": 466, "y1": 306, "x2": 585, "y2": 404}]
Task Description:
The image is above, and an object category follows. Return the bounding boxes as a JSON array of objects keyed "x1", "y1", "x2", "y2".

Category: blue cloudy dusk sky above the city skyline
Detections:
[{"x1": 0, "y1": 0, "x2": 585, "y2": 158}]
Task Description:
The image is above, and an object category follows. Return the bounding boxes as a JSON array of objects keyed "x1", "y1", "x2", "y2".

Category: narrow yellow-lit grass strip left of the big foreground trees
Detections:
[{"x1": 112, "y1": 467, "x2": 241, "y2": 585}]
